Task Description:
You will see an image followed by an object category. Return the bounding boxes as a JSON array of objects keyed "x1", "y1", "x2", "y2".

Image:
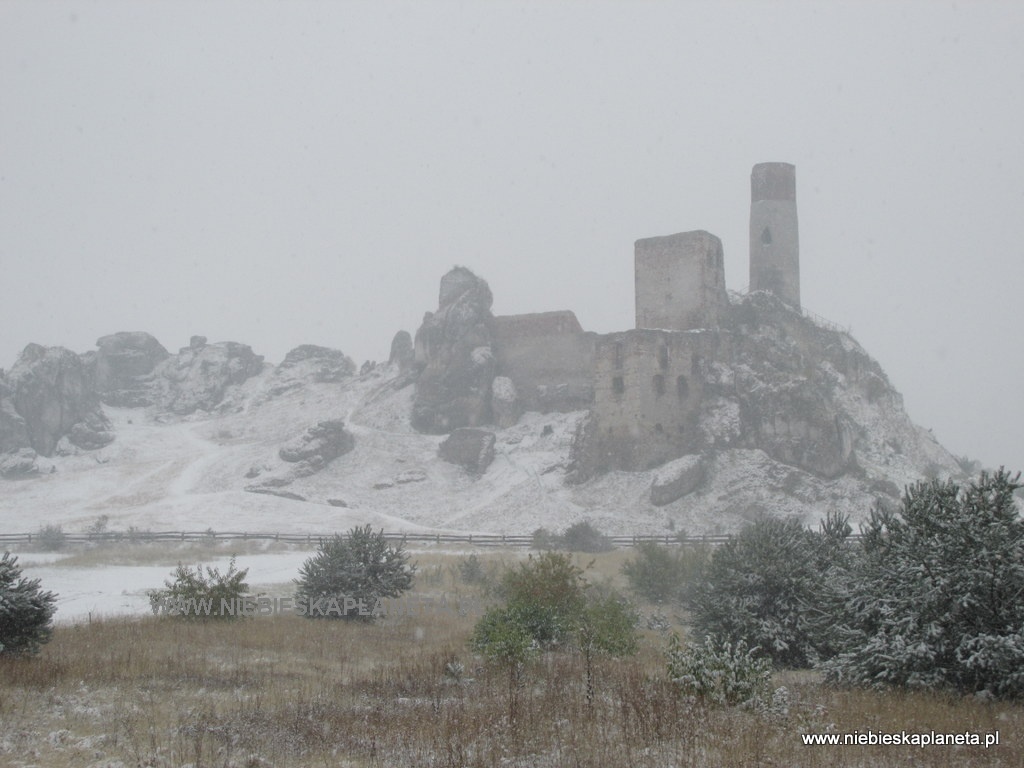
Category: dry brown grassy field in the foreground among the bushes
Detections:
[{"x1": 0, "y1": 550, "x2": 1024, "y2": 768}]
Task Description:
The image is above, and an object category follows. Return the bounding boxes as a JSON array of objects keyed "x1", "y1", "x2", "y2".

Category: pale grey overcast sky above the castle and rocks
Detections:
[{"x1": 0, "y1": 0, "x2": 1024, "y2": 469}]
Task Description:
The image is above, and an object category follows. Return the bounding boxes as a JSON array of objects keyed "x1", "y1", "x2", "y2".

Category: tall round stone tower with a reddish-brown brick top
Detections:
[{"x1": 750, "y1": 163, "x2": 800, "y2": 309}]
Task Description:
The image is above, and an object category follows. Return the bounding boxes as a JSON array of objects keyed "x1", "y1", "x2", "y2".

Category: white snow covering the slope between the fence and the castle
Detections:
[{"x1": 0, "y1": 354, "x2": 966, "y2": 548}]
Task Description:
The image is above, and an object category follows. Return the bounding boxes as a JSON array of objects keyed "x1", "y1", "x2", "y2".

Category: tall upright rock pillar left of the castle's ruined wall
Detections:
[{"x1": 412, "y1": 267, "x2": 495, "y2": 434}]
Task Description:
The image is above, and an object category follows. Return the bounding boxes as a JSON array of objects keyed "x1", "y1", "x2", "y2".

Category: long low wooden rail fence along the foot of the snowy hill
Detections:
[{"x1": 0, "y1": 530, "x2": 728, "y2": 547}]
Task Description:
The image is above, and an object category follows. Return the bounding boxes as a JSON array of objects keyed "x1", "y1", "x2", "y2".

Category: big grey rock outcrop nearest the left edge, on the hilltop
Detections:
[{"x1": 0, "y1": 344, "x2": 114, "y2": 456}]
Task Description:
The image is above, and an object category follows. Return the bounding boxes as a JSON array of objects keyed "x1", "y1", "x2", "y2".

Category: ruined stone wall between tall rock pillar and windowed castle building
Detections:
[{"x1": 494, "y1": 311, "x2": 597, "y2": 413}]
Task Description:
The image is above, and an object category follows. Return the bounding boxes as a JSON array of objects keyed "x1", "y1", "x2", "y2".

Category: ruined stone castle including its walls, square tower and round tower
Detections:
[{"x1": 413, "y1": 163, "x2": 815, "y2": 474}]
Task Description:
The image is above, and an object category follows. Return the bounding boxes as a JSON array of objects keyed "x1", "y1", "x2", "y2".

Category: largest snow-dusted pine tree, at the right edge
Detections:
[{"x1": 824, "y1": 469, "x2": 1024, "y2": 698}]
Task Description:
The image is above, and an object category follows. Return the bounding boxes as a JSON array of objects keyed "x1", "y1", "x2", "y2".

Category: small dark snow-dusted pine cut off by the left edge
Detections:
[{"x1": 0, "y1": 552, "x2": 57, "y2": 654}]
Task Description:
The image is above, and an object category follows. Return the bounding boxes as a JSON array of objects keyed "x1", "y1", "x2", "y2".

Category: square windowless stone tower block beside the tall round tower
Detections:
[{"x1": 635, "y1": 229, "x2": 729, "y2": 331}]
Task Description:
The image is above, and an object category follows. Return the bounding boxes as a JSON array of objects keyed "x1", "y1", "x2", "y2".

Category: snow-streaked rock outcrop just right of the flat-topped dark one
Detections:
[{"x1": 158, "y1": 337, "x2": 263, "y2": 416}]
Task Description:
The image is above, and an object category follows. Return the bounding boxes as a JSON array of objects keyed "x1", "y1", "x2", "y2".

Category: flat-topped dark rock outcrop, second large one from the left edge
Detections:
[{"x1": 86, "y1": 332, "x2": 170, "y2": 408}]
